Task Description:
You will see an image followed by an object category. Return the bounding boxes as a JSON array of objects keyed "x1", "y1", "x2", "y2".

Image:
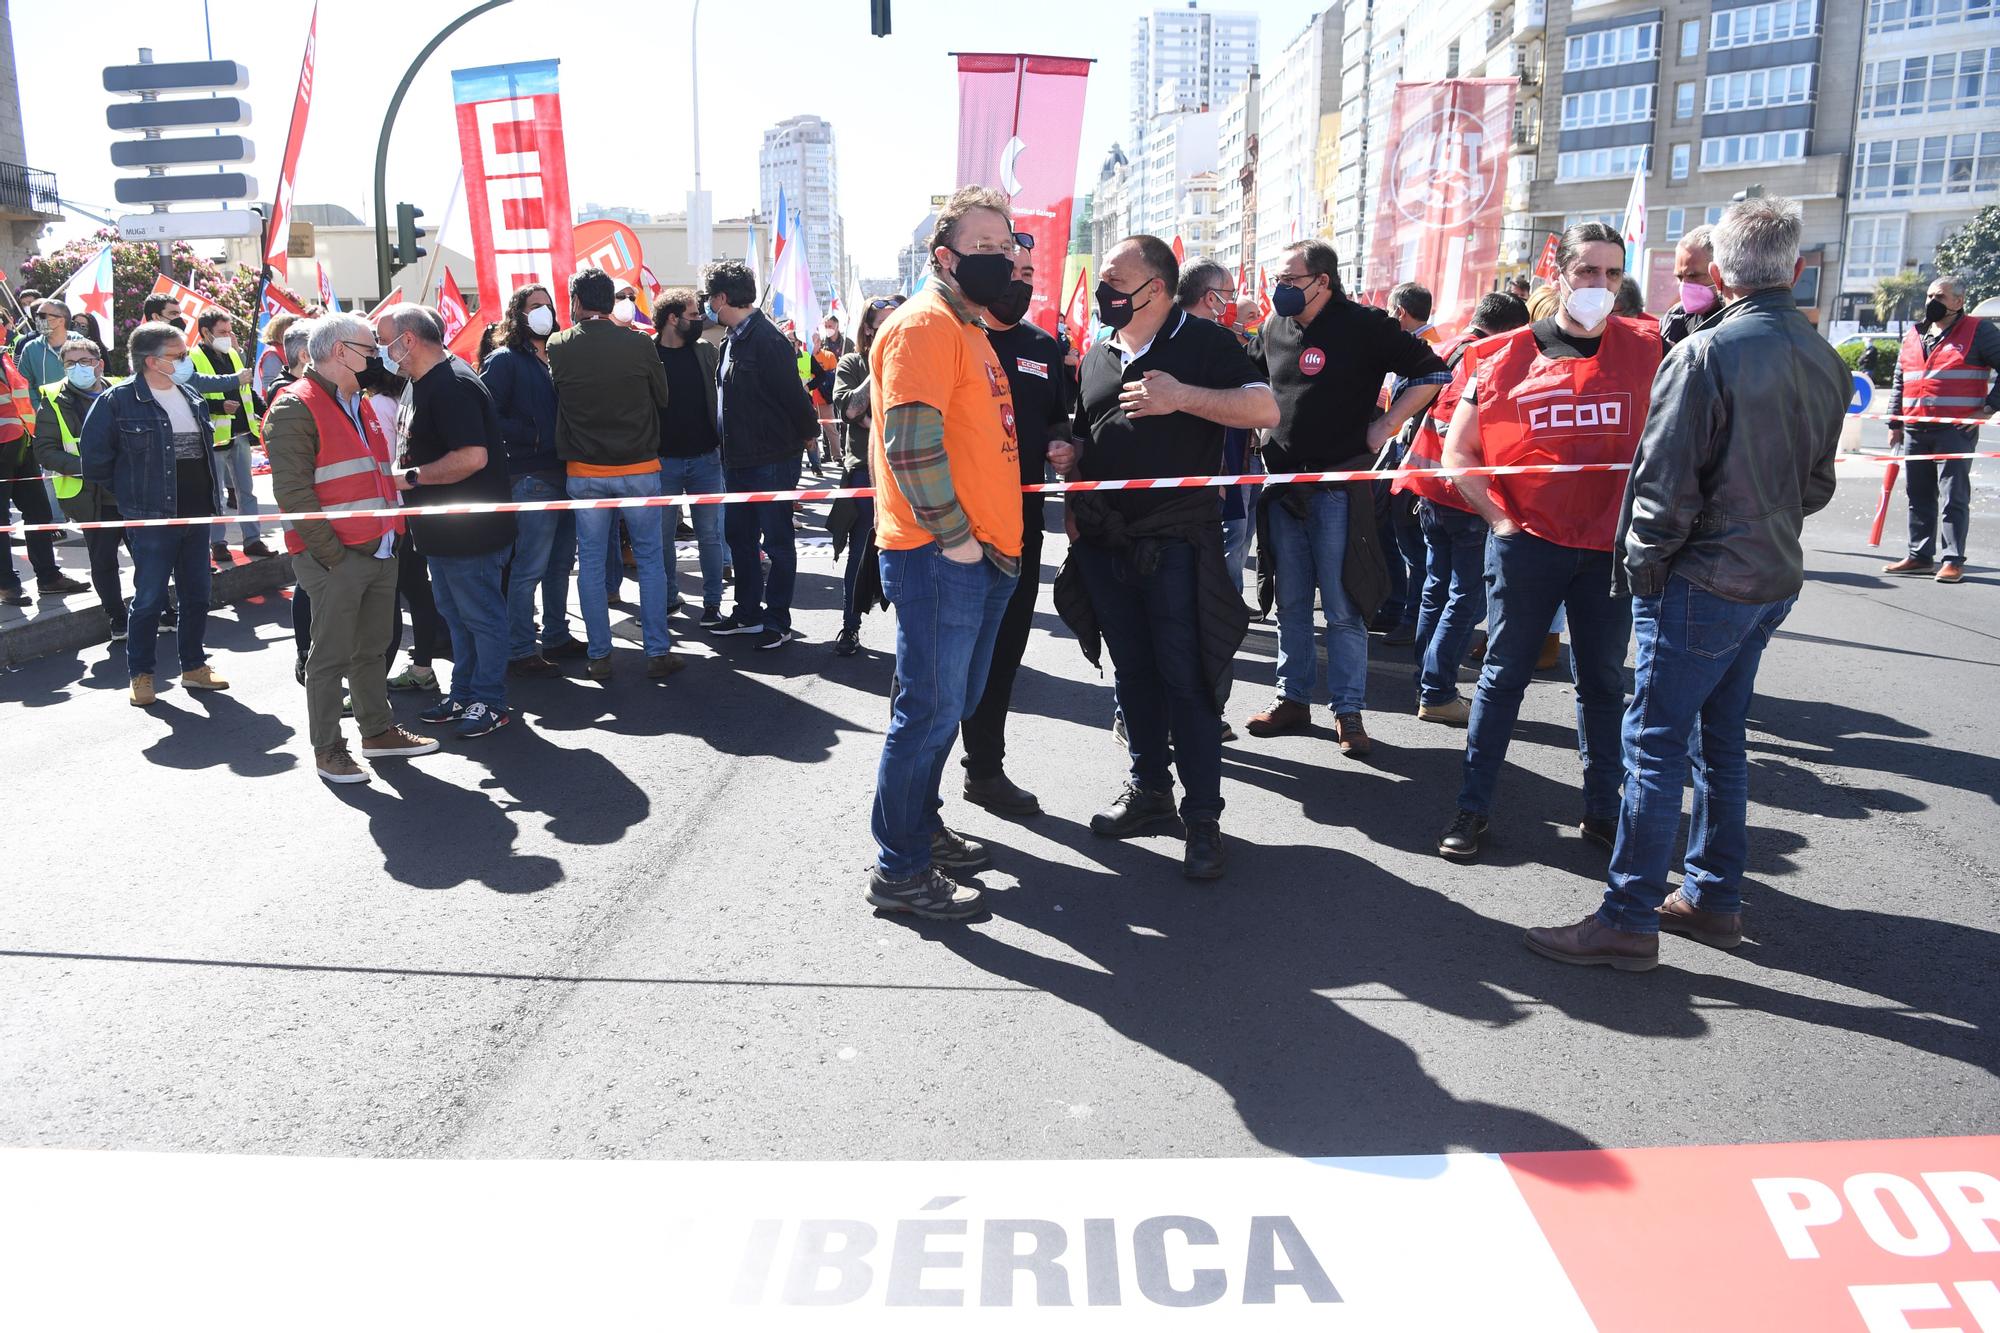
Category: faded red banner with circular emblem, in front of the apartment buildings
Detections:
[{"x1": 1364, "y1": 78, "x2": 1514, "y2": 328}]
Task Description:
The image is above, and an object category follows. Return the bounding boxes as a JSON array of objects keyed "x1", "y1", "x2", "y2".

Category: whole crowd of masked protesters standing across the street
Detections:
[{"x1": 0, "y1": 188, "x2": 2000, "y2": 971}]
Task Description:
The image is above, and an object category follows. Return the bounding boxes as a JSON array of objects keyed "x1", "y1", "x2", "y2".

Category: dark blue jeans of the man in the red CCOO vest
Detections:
[{"x1": 1458, "y1": 532, "x2": 1632, "y2": 819}]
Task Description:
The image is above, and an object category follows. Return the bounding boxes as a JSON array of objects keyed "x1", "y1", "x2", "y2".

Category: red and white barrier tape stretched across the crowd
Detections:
[{"x1": 0, "y1": 450, "x2": 2000, "y2": 536}]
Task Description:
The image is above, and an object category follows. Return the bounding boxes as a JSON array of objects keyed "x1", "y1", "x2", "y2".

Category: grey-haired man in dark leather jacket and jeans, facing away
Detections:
[{"x1": 1528, "y1": 196, "x2": 1852, "y2": 971}]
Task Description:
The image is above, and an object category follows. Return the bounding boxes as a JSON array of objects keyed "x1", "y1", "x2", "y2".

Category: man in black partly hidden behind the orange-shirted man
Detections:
[{"x1": 958, "y1": 250, "x2": 1072, "y2": 815}]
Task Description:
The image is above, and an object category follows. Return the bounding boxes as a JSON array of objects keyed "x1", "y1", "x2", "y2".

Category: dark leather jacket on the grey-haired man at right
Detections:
[{"x1": 1616, "y1": 288, "x2": 1854, "y2": 602}]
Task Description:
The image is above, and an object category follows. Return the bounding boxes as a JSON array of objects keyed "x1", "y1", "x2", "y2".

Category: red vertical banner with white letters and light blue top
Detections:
[{"x1": 452, "y1": 60, "x2": 576, "y2": 322}]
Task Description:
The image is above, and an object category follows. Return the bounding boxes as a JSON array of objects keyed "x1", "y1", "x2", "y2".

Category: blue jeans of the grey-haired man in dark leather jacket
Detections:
[{"x1": 1598, "y1": 578, "x2": 1798, "y2": 933}]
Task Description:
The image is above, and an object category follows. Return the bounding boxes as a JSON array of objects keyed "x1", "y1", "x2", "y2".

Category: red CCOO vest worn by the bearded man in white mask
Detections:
[{"x1": 1462, "y1": 320, "x2": 1660, "y2": 550}]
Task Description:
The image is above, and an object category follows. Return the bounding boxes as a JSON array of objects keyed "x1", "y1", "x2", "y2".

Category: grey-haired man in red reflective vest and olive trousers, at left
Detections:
[{"x1": 264, "y1": 314, "x2": 438, "y2": 783}]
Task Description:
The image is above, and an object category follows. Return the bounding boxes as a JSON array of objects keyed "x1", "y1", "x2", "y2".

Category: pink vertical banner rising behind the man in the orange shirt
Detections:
[{"x1": 958, "y1": 56, "x2": 1090, "y2": 332}]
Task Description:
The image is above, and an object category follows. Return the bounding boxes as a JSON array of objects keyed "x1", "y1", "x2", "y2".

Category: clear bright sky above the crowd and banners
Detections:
[{"x1": 12, "y1": 0, "x2": 1326, "y2": 280}]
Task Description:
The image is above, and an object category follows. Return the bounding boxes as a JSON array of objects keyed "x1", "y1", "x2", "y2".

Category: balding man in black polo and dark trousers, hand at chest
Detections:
[{"x1": 1048, "y1": 236, "x2": 1278, "y2": 879}]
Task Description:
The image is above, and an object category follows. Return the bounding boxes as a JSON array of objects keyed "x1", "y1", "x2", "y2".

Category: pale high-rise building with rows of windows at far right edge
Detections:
[{"x1": 1822, "y1": 0, "x2": 2000, "y2": 322}]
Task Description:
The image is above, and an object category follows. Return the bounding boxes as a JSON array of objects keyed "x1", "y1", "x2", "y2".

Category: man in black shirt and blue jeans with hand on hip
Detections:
[{"x1": 1248, "y1": 240, "x2": 1452, "y2": 759}]
